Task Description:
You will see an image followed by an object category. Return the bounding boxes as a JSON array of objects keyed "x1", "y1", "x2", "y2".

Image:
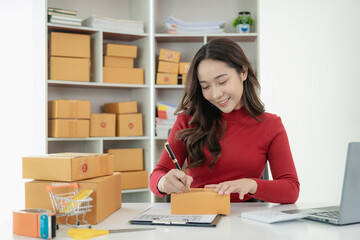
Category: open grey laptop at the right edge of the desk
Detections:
[{"x1": 307, "y1": 142, "x2": 360, "y2": 225}]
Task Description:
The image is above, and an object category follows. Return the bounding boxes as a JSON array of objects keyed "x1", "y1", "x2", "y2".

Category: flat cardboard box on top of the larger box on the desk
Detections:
[{"x1": 22, "y1": 153, "x2": 114, "y2": 182}]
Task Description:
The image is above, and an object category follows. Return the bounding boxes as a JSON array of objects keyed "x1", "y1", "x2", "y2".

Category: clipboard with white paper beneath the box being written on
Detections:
[{"x1": 129, "y1": 203, "x2": 223, "y2": 227}]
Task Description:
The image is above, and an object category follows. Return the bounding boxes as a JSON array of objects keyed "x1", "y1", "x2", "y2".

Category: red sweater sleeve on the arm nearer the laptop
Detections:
[{"x1": 249, "y1": 116, "x2": 300, "y2": 203}]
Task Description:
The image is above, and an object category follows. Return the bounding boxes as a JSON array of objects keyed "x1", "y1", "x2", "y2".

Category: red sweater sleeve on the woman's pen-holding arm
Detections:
[{"x1": 150, "y1": 113, "x2": 188, "y2": 197}]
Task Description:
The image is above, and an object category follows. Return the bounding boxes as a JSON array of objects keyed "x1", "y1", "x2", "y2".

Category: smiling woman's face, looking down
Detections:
[{"x1": 198, "y1": 59, "x2": 247, "y2": 113}]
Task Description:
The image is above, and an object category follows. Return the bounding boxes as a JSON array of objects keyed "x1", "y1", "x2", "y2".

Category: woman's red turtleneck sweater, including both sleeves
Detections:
[{"x1": 150, "y1": 107, "x2": 300, "y2": 203}]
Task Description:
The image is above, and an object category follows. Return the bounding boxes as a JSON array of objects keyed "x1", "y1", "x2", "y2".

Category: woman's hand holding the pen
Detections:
[{"x1": 157, "y1": 169, "x2": 193, "y2": 194}]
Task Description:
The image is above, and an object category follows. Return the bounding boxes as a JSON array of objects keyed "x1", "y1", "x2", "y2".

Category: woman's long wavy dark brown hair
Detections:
[{"x1": 176, "y1": 38, "x2": 265, "y2": 169}]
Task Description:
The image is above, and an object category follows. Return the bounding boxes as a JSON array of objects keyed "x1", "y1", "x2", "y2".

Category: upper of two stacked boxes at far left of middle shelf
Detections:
[{"x1": 48, "y1": 100, "x2": 90, "y2": 119}]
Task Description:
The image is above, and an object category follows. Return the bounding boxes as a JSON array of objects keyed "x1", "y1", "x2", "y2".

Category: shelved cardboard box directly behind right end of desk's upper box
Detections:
[{"x1": 105, "y1": 148, "x2": 144, "y2": 172}]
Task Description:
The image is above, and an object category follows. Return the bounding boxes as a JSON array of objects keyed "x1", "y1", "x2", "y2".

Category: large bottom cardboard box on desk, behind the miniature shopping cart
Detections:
[{"x1": 25, "y1": 173, "x2": 121, "y2": 224}]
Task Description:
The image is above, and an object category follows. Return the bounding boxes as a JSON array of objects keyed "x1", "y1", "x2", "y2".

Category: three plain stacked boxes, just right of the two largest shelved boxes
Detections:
[{"x1": 103, "y1": 43, "x2": 144, "y2": 84}]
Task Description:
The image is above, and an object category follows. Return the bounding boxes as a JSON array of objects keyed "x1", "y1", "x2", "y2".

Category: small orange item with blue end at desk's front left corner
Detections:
[{"x1": 13, "y1": 209, "x2": 56, "y2": 239}]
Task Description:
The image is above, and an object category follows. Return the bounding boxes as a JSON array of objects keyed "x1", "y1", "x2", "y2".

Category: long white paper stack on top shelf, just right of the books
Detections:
[{"x1": 83, "y1": 15, "x2": 144, "y2": 34}]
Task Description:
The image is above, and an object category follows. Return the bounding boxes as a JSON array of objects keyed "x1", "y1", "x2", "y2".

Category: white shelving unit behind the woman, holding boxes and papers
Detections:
[{"x1": 44, "y1": 0, "x2": 258, "y2": 202}]
